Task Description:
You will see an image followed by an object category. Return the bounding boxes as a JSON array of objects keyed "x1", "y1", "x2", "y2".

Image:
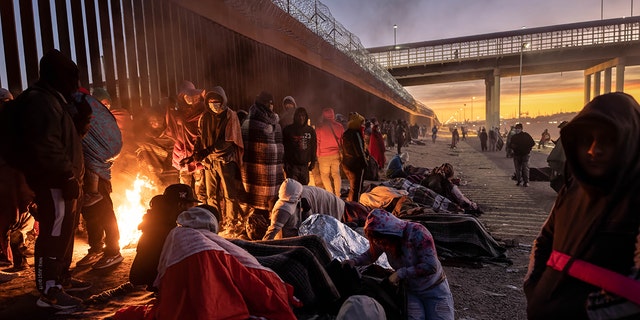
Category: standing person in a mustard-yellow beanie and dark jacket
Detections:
[{"x1": 342, "y1": 112, "x2": 369, "y2": 202}]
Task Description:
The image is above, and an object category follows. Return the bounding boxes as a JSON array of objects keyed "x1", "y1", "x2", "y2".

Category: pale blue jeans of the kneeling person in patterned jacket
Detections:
[{"x1": 407, "y1": 279, "x2": 454, "y2": 320}]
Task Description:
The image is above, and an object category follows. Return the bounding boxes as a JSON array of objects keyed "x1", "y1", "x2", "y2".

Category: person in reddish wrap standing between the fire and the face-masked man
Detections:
[{"x1": 165, "y1": 81, "x2": 206, "y2": 202}]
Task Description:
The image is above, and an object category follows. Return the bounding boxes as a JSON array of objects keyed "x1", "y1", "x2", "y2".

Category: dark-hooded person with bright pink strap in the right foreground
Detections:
[{"x1": 523, "y1": 92, "x2": 640, "y2": 320}]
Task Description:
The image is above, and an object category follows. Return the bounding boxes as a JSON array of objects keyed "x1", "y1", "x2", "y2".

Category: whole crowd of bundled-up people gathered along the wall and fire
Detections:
[{"x1": 0, "y1": 50, "x2": 640, "y2": 319}]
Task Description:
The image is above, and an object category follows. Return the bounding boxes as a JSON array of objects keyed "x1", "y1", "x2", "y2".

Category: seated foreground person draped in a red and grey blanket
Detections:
[{"x1": 113, "y1": 207, "x2": 297, "y2": 320}]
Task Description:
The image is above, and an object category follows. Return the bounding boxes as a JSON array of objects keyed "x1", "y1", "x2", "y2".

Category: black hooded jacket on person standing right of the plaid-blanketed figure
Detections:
[{"x1": 282, "y1": 108, "x2": 318, "y2": 165}]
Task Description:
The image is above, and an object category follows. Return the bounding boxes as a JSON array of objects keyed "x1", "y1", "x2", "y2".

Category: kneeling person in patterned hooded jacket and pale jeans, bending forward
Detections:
[{"x1": 343, "y1": 209, "x2": 454, "y2": 319}]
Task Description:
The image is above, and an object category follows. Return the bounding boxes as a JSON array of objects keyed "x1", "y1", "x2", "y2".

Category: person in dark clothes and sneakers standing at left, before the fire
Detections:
[{"x1": 11, "y1": 49, "x2": 91, "y2": 309}]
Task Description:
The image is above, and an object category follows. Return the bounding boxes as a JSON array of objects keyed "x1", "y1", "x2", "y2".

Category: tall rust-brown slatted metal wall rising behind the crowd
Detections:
[{"x1": 0, "y1": 0, "x2": 428, "y2": 125}]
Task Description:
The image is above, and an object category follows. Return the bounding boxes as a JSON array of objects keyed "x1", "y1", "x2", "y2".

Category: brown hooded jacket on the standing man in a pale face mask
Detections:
[{"x1": 195, "y1": 86, "x2": 244, "y2": 168}]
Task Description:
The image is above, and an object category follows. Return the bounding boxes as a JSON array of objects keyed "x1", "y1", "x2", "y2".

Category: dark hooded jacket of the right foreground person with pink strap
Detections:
[{"x1": 524, "y1": 93, "x2": 640, "y2": 319}]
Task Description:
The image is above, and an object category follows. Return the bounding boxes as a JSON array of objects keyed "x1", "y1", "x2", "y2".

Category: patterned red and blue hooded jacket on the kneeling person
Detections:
[{"x1": 354, "y1": 209, "x2": 444, "y2": 292}]
